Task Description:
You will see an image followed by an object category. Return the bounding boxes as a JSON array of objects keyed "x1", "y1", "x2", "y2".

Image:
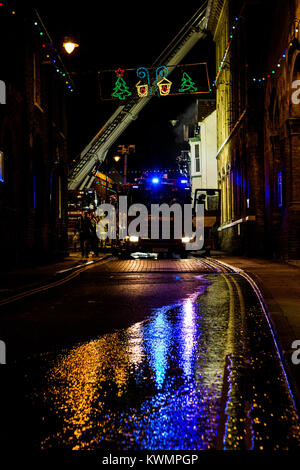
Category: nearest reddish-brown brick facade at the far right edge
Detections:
[{"x1": 263, "y1": 0, "x2": 300, "y2": 260}]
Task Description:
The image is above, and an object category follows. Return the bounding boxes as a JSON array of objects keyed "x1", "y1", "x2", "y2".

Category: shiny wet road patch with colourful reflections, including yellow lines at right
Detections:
[{"x1": 24, "y1": 275, "x2": 300, "y2": 450}]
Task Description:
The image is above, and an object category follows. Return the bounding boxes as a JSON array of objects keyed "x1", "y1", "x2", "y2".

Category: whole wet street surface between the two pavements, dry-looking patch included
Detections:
[{"x1": 0, "y1": 260, "x2": 300, "y2": 450}]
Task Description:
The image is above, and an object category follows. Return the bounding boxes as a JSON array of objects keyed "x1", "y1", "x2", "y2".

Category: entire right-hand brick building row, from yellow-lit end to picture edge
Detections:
[{"x1": 207, "y1": 0, "x2": 300, "y2": 259}]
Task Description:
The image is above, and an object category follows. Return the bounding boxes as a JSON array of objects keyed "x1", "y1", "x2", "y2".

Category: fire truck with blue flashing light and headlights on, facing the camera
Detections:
[{"x1": 114, "y1": 174, "x2": 220, "y2": 258}]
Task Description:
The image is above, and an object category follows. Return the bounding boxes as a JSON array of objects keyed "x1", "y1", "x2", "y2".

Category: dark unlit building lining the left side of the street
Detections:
[{"x1": 0, "y1": 6, "x2": 72, "y2": 268}]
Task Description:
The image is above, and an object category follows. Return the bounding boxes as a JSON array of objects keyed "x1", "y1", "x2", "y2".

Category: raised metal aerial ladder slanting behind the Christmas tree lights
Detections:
[{"x1": 68, "y1": 1, "x2": 207, "y2": 190}]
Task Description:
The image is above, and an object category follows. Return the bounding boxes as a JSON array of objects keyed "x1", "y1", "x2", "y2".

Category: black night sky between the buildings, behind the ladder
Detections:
[{"x1": 29, "y1": 0, "x2": 213, "y2": 168}]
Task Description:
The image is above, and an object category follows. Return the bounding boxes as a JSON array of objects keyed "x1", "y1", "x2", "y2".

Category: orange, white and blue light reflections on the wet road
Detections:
[{"x1": 42, "y1": 282, "x2": 226, "y2": 449}]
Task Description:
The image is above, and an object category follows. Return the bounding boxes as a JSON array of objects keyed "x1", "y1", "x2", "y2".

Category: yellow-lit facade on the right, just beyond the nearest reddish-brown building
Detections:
[{"x1": 208, "y1": 0, "x2": 264, "y2": 255}]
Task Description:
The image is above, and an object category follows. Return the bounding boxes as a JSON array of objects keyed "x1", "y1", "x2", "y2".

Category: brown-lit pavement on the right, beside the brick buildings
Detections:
[{"x1": 214, "y1": 255, "x2": 300, "y2": 403}]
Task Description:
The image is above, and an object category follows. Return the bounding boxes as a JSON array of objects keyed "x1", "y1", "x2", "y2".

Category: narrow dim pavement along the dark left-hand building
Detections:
[{"x1": 0, "y1": 252, "x2": 109, "y2": 299}]
